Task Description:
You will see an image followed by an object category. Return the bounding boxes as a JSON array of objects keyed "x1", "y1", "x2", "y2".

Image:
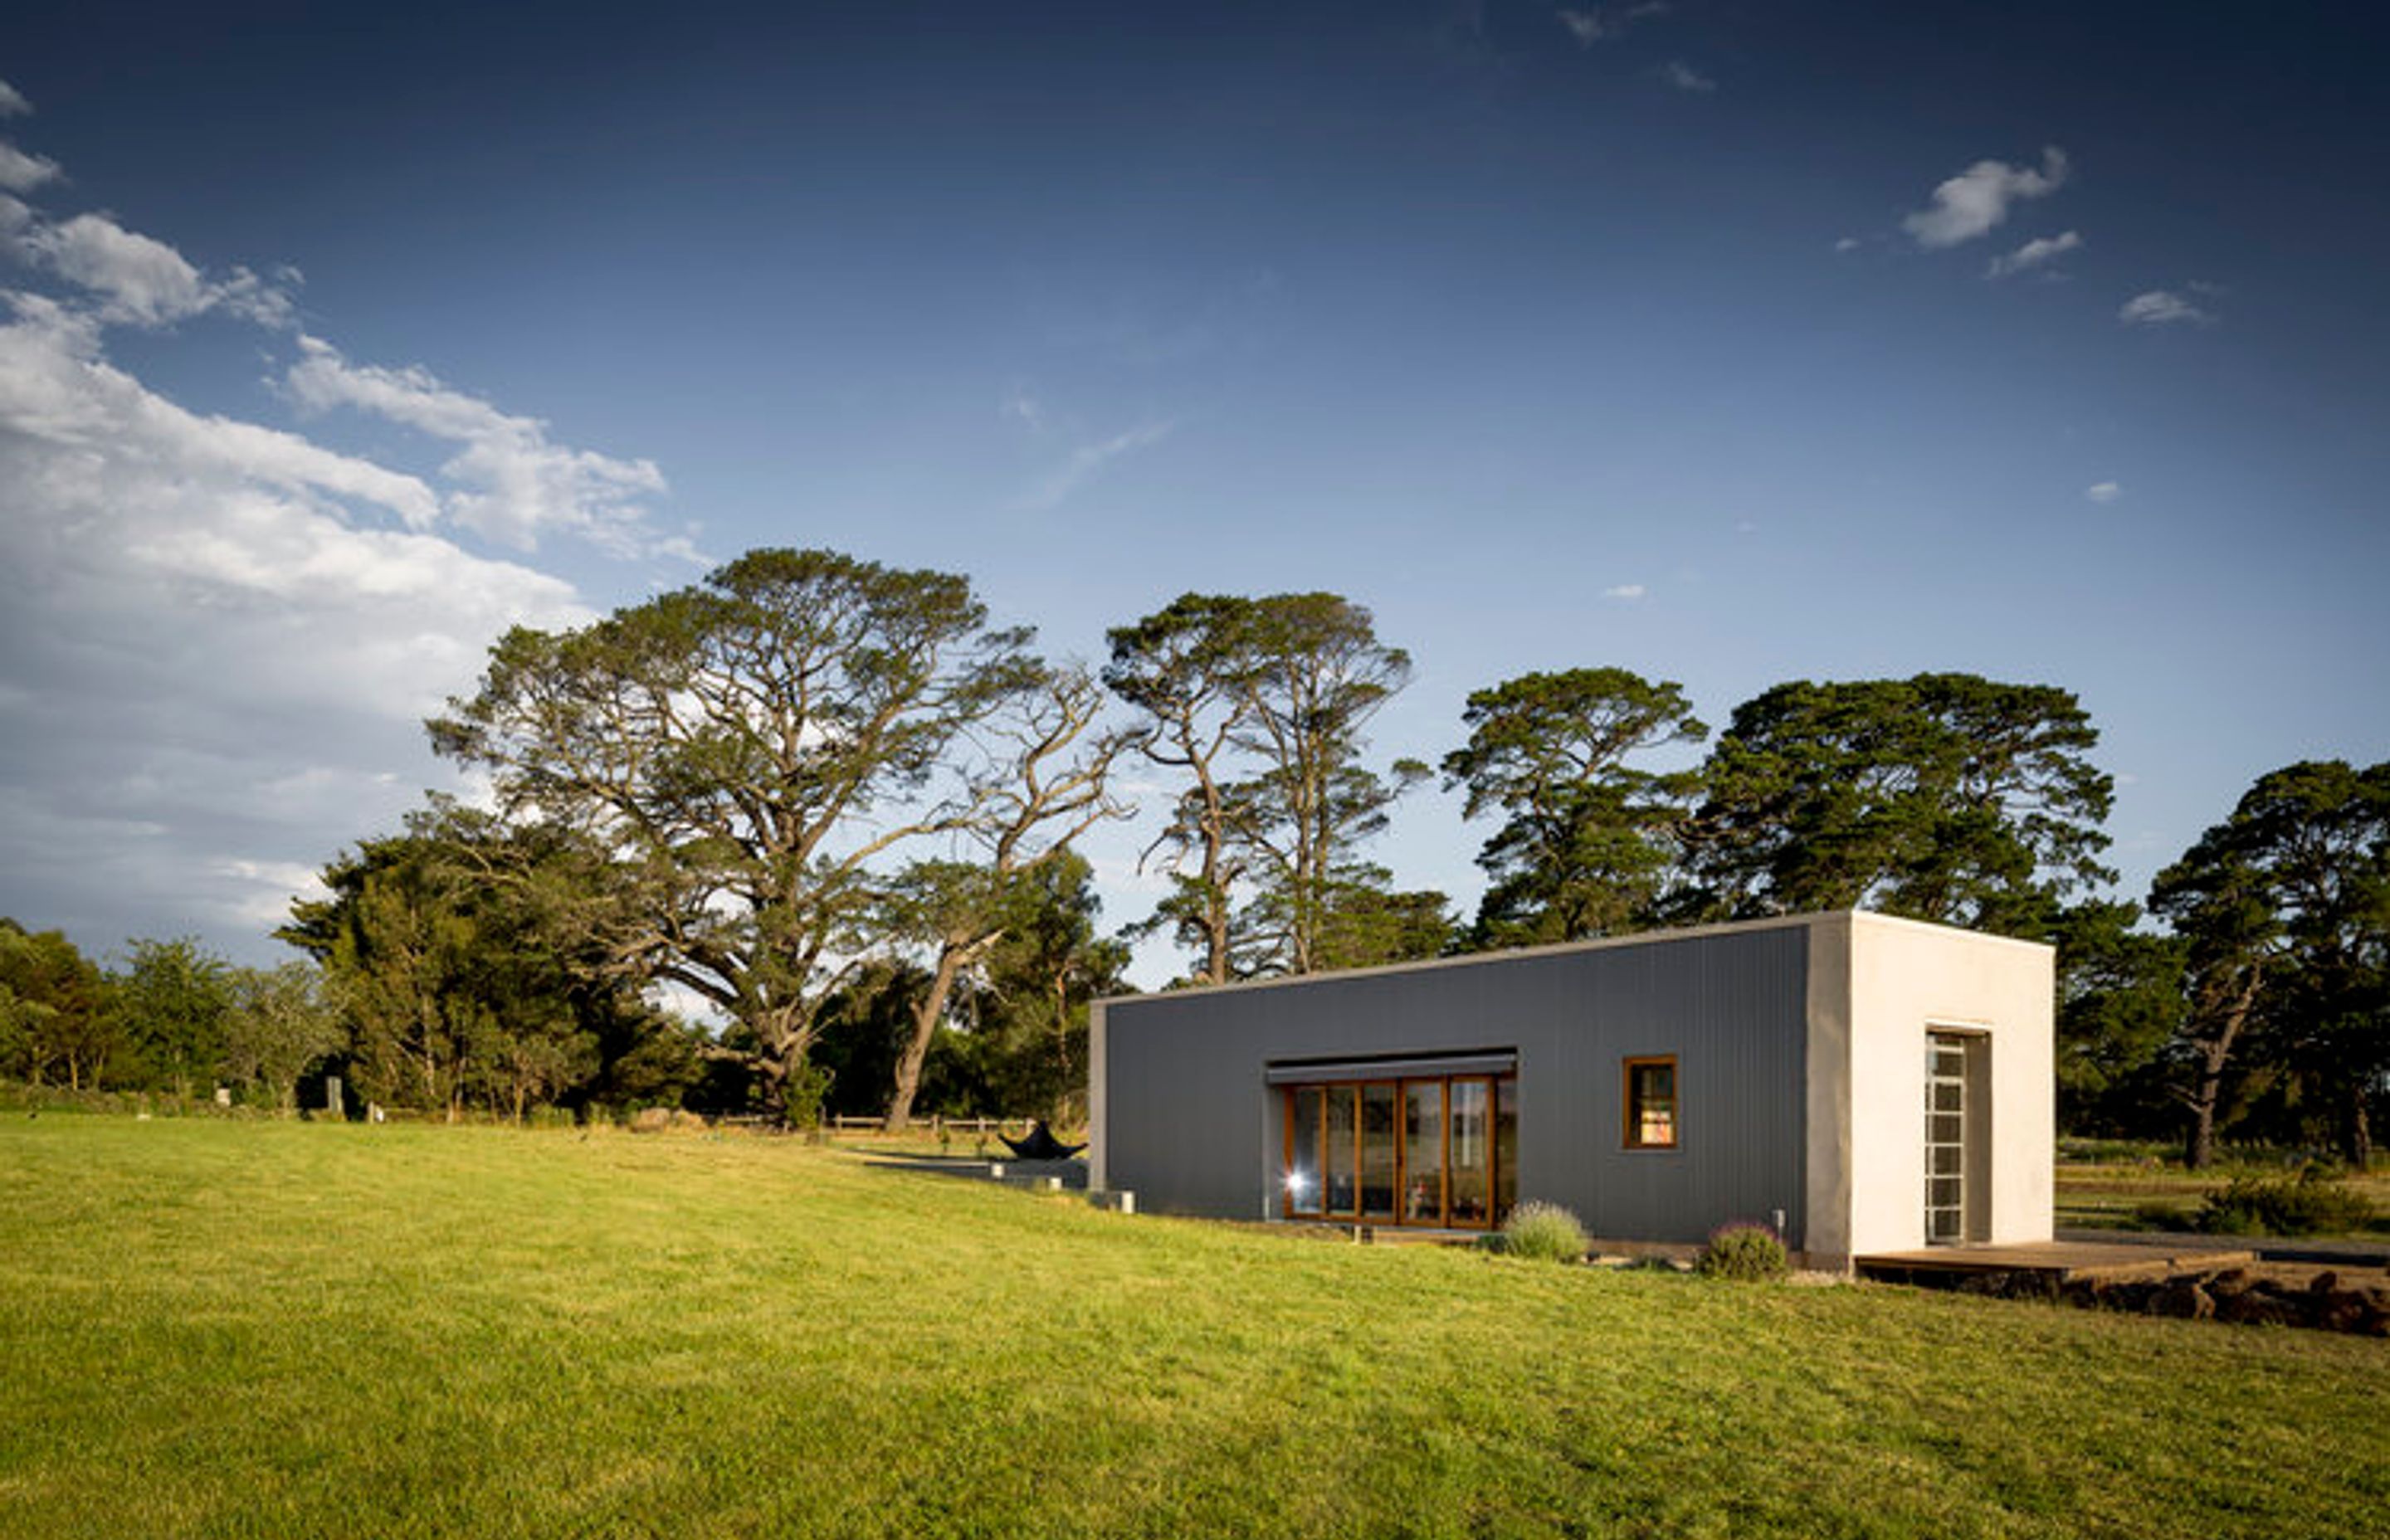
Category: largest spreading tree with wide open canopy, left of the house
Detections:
[{"x1": 430, "y1": 550, "x2": 1037, "y2": 1122}]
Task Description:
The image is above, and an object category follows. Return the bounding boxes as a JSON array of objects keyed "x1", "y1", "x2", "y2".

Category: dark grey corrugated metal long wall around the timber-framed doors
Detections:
[{"x1": 1106, "y1": 923, "x2": 1809, "y2": 1246}]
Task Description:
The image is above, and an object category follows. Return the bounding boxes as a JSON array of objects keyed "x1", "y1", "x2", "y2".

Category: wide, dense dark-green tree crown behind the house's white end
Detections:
[{"x1": 1685, "y1": 675, "x2": 2115, "y2": 938}]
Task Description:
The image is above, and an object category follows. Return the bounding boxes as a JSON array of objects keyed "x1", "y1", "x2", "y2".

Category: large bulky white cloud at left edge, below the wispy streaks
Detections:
[{"x1": 0, "y1": 275, "x2": 588, "y2": 947}]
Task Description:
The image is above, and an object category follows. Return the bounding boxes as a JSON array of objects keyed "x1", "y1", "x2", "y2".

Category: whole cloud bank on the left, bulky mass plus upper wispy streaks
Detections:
[{"x1": 0, "y1": 86, "x2": 669, "y2": 957}]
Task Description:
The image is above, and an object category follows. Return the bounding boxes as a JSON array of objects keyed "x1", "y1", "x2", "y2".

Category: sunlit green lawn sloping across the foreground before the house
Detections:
[{"x1": 0, "y1": 1117, "x2": 2390, "y2": 1540}]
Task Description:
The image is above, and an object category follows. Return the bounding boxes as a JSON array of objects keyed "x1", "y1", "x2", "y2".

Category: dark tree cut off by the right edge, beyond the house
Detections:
[{"x1": 2149, "y1": 760, "x2": 2390, "y2": 1167}]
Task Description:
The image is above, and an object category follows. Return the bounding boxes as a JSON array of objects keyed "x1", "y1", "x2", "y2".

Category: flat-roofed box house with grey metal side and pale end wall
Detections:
[{"x1": 1087, "y1": 911, "x2": 2056, "y2": 1267}]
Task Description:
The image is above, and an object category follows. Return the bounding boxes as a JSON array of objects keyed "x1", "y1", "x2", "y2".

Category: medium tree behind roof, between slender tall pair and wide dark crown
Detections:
[{"x1": 1444, "y1": 667, "x2": 1709, "y2": 944}]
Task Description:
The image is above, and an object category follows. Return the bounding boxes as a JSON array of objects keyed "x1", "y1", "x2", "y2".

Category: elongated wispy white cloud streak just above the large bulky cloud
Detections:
[{"x1": 285, "y1": 337, "x2": 686, "y2": 555}]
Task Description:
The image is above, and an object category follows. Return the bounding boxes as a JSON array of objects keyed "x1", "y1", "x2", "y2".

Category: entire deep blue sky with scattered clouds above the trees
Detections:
[{"x1": 0, "y1": 0, "x2": 2390, "y2": 981}]
